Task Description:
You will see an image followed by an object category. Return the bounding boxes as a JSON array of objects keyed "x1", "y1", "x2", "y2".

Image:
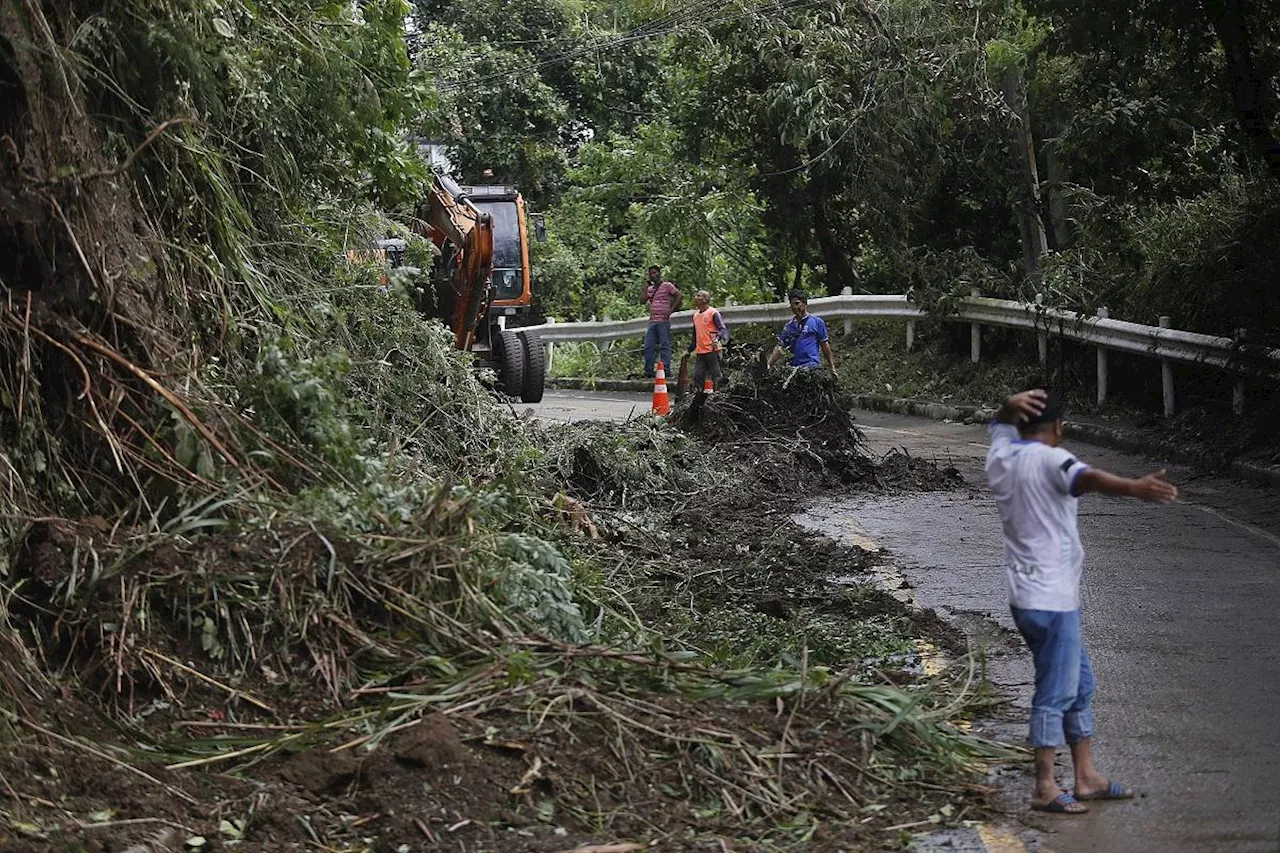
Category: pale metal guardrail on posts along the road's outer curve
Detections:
[{"x1": 514, "y1": 293, "x2": 1280, "y2": 415}]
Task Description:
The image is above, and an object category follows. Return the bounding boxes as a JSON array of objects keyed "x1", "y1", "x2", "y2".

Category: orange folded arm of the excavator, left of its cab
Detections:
[{"x1": 417, "y1": 175, "x2": 493, "y2": 350}]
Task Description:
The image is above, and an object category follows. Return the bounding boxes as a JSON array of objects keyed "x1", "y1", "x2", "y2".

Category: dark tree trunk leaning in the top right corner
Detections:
[{"x1": 1201, "y1": 0, "x2": 1280, "y2": 177}]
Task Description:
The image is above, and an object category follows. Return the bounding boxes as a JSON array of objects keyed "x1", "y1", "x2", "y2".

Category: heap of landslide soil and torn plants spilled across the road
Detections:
[{"x1": 0, "y1": 424, "x2": 986, "y2": 852}]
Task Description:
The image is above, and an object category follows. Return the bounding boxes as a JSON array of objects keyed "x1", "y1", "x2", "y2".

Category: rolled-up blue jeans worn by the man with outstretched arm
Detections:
[{"x1": 1009, "y1": 607, "x2": 1093, "y2": 747}]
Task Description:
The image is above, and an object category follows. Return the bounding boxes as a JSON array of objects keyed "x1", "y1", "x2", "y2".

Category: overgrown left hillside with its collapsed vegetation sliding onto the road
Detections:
[{"x1": 0, "y1": 0, "x2": 996, "y2": 853}]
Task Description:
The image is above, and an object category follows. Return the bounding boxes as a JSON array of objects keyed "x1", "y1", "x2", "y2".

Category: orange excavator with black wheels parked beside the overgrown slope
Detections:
[{"x1": 409, "y1": 174, "x2": 547, "y2": 402}]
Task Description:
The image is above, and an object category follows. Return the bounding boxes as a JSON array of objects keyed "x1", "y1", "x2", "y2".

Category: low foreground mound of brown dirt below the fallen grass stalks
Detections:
[{"x1": 0, "y1": 666, "x2": 988, "y2": 853}]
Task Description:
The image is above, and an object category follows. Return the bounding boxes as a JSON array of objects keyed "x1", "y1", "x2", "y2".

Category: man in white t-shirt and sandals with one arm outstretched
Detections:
[{"x1": 987, "y1": 388, "x2": 1178, "y2": 815}]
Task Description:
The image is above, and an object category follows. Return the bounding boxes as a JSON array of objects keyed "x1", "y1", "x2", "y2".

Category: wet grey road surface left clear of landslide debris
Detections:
[{"x1": 524, "y1": 392, "x2": 1280, "y2": 853}]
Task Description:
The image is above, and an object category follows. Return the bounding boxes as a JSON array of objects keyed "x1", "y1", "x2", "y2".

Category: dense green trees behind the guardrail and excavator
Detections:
[{"x1": 415, "y1": 0, "x2": 1280, "y2": 334}]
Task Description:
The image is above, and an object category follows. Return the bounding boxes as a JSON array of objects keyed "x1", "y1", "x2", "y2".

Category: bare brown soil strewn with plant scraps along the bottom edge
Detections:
[{"x1": 0, "y1": 689, "x2": 967, "y2": 853}]
